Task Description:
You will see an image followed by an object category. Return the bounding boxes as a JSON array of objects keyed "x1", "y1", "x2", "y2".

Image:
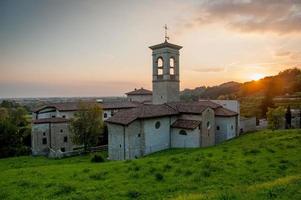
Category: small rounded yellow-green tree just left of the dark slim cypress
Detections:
[{"x1": 267, "y1": 106, "x2": 285, "y2": 130}]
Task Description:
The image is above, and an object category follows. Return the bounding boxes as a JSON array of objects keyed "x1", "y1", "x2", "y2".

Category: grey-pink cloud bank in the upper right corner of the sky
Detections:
[{"x1": 185, "y1": 0, "x2": 301, "y2": 35}]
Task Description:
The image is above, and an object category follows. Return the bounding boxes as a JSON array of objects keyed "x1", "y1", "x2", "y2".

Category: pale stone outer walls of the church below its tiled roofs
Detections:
[{"x1": 108, "y1": 108, "x2": 227, "y2": 160}]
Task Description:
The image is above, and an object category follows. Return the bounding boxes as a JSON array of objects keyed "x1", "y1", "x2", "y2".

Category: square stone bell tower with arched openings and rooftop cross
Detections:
[{"x1": 149, "y1": 26, "x2": 182, "y2": 104}]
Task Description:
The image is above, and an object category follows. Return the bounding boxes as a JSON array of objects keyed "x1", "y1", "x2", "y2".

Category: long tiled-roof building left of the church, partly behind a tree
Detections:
[{"x1": 32, "y1": 101, "x2": 140, "y2": 155}]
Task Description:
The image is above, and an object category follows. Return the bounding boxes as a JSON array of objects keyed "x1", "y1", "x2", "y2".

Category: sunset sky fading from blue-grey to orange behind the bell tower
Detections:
[{"x1": 0, "y1": 0, "x2": 301, "y2": 98}]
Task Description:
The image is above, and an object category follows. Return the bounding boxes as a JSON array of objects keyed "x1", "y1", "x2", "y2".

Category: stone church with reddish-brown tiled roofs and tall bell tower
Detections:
[{"x1": 106, "y1": 40, "x2": 239, "y2": 160}]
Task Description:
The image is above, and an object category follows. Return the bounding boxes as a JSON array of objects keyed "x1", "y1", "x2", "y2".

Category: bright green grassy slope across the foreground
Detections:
[{"x1": 0, "y1": 130, "x2": 301, "y2": 200}]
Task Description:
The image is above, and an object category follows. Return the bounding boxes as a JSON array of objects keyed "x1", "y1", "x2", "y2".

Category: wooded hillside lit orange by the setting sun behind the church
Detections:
[{"x1": 181, "y1": 68, "x2": 301, "y2": 118}]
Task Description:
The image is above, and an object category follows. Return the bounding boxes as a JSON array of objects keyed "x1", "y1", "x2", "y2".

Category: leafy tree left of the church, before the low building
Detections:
[{"x1": 70, "y1": 102, "x2": 103, "y2": 152}]
